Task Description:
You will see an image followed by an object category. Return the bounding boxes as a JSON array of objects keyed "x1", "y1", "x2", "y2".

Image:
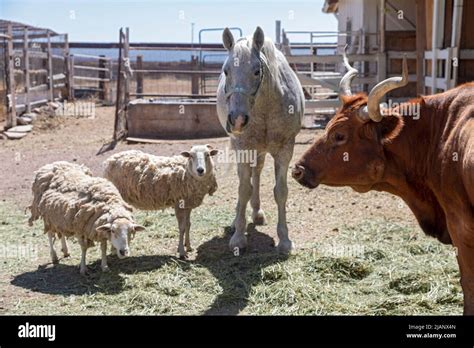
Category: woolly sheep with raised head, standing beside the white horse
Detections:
[{"x1": 104, "y1": 145, "x2": 218, "y2": 259}]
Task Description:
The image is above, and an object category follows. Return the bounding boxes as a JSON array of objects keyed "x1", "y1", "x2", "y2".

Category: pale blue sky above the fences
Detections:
[{"x1": 0, "y1": 0, "x2": 337, "y2": 42}]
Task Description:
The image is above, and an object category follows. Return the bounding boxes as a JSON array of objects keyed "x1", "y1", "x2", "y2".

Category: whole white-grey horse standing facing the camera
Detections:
[{"x1": 217, "y1": 27, "x2": 304, "y2": 253}]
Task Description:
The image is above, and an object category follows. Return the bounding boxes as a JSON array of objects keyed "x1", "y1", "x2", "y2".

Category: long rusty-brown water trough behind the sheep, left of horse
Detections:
[{"x1": 127, "y1": 98, "x2": 226, "y2": 139}]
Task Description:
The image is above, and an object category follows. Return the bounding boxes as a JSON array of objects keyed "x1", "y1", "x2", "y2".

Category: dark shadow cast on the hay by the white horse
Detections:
[{"x1": 195, "y1": 224, "x2": 288, "y2": 315}]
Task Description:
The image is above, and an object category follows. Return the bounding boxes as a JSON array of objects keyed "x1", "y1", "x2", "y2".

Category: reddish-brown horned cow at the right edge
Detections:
[{"x1": 292, "y1": 51, "x2": 474, "y2": 315}]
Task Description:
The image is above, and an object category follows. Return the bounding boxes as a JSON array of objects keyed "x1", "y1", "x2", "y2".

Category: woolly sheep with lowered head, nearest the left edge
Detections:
[{"x1": 28, "y1": 161, "x2": 145, "y2": 275}]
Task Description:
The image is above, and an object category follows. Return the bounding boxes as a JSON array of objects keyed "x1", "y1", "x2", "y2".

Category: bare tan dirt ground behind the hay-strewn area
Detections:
[{"x1": 0, "y1": 107, "x2": 416, "y2": 247}]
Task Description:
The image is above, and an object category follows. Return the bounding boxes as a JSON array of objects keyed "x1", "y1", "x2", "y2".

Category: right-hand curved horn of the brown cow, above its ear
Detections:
[{"x1": 359, "y1": 55, "x2": 408, "y2": 122}]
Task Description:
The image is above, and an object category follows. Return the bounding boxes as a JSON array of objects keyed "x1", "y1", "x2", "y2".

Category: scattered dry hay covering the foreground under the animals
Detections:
[{"x1": 0, "y1": 197, "x2": 462, "y2": 315}]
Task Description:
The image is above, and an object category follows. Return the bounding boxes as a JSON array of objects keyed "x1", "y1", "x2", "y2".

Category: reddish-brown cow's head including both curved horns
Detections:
[{"x1": 292, "y1": 48, "x2": 408, "y2": 192}]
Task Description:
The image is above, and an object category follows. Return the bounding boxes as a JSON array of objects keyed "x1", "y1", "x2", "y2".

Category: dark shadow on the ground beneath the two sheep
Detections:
[{"x1": 11, "y1": 255, "x2": 182, "y2": 296}]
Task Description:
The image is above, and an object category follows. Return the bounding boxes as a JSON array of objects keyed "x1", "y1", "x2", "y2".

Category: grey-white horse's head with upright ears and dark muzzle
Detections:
[{"x1": 222, "y1": 27, "x2": 267, "y2": 134}]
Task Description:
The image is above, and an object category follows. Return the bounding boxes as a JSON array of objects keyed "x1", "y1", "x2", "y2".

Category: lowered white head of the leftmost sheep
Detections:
[{"x1": 96, "y1": 218, "x2": 145, "y2": 259}]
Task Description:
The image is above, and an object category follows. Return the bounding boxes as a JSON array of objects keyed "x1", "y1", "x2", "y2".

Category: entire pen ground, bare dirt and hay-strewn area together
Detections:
[{"x1": 0, "y1": 107, "x2": 462, "y2": 315}]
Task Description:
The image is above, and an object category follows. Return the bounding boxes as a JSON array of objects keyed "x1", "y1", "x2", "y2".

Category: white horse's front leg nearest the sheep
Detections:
[{"x1": 229, "y1": 163, "x2": 252, "y2": 254}]
